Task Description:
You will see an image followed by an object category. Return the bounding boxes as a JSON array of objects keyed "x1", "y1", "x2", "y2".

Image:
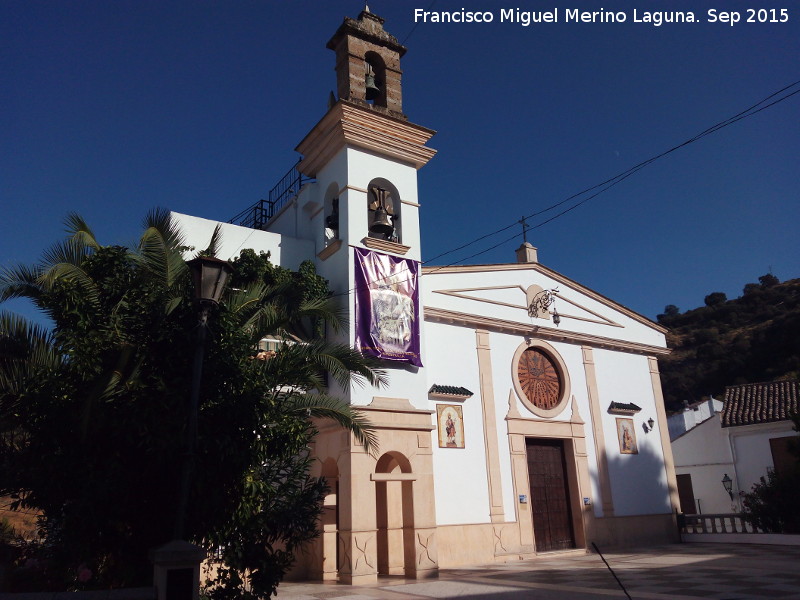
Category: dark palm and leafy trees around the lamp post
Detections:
[{"x1": 0, "y1": 211, "x2": 384, "y2": 598}]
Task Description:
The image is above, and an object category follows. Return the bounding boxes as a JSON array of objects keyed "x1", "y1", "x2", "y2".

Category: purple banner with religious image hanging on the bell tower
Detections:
[{"x1": 355, "y1": 248, "x2": 422, "y2": 367}]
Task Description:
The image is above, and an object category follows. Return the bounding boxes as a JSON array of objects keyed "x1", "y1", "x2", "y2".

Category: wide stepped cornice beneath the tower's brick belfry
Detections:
[{"x1": 295, "y1": 100, "x2": 436, "y2": 177}]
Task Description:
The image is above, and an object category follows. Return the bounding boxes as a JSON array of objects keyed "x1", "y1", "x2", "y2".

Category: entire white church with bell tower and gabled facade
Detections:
[{"x1": 174, "y1": 10, "x2": 678, "y2": 583}]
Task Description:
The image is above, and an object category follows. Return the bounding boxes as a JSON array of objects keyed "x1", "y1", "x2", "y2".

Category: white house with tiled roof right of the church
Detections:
[{"x1": 672, "y1": 381, "x2": 800, "y2": 514}]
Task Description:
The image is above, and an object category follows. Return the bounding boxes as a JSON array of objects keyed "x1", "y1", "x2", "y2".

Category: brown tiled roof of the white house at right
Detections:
[{"x1": 722, "y1": 381, "x2": 800, "y2": 427}]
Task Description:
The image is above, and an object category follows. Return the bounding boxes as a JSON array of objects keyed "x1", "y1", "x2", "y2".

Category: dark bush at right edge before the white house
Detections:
[{"x1": 742, "y1": 415, "x2": 800, "y2": 533}]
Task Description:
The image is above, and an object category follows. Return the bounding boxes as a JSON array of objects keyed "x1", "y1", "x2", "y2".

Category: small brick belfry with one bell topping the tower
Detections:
[{"x1": 326, "y1": 7, "x2": 408, "y2": 120}]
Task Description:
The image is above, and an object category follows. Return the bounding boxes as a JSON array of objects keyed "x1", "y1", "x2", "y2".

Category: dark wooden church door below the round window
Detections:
[{"x1": 526, "y1": 438, "x2": 575, "y2": 552}]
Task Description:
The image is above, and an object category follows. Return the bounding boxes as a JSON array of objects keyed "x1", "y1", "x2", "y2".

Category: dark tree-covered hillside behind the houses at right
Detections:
[{"x1": 658, "y1": 274, "x2": 800, "y2": 411}]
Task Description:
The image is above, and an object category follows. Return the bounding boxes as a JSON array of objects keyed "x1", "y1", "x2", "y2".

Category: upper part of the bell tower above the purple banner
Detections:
[{"x1": 296, "y1": 8, "x2": 436, "y2": 264}]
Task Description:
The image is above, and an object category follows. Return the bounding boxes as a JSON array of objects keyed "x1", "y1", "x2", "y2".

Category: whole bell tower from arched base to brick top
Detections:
[{"x1": 290, "y1": 9, "x2": 438, "y2": 584}]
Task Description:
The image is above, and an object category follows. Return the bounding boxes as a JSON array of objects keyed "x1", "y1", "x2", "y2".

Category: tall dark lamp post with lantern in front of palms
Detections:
[{"x1": 175, "y1": 256, "x2": 228, "y2": 540}]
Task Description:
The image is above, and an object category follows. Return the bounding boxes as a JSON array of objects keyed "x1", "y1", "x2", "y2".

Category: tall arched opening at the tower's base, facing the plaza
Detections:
[{"x1": 375, "y1": 452, "x2": 415, "y2": 577}]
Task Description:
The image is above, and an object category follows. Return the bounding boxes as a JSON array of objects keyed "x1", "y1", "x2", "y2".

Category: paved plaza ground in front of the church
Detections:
[{"x1": 278, "y1": 544, "x2": 800, "y2": 600}]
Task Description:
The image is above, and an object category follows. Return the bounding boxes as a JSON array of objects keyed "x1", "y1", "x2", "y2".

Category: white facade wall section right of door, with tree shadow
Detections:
[{"x1": 594, "y1": 349, "x2": 671, "y2": 516}]
